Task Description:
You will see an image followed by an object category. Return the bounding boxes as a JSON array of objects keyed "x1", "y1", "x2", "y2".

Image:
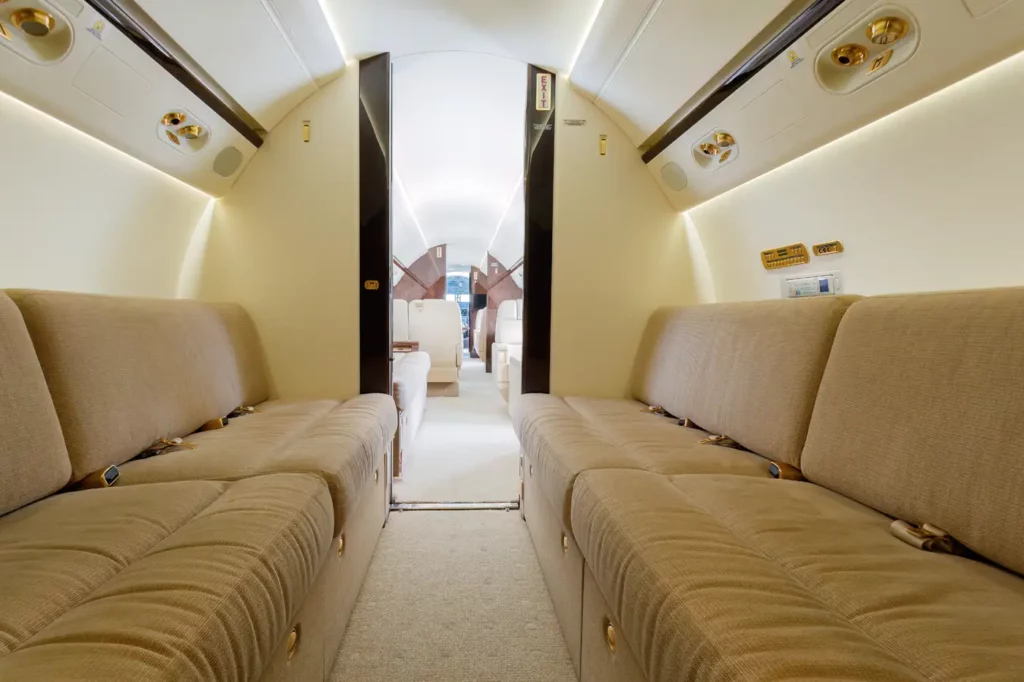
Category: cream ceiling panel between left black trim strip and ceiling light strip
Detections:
[{"x1": 136, "y1": 0, "x2": 337, "y2": 130}]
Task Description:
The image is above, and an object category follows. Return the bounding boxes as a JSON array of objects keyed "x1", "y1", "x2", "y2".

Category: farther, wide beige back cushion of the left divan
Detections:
[{"x1": 11, "y1": 292, "x2": 268, "y2": 480}]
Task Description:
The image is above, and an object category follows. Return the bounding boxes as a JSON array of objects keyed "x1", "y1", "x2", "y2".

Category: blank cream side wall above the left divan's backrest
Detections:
[{"x1": 0, "y1": 93, "x2": 210, "y2": 297}]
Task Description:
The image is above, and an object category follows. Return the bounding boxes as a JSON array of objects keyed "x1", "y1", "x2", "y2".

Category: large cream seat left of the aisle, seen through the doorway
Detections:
[{"x1": 409, "y1": 300, "x2": 463, "y2": 384}]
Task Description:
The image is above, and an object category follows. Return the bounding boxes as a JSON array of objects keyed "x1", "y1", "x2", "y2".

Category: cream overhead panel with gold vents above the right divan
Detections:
[{"x1": 648, "y1": 0, "x2": 1024, "y2": 210}]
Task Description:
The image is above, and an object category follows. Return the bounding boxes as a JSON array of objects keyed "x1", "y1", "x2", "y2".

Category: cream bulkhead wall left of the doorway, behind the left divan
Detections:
[{"x1": 200, "y1": 69, "x2": 359, "y2": 399}]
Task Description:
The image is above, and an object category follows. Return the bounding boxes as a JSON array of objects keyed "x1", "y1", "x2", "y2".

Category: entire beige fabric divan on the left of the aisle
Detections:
[{"x1": 0, "y1": 292, "x2": 397, "y2": 682}]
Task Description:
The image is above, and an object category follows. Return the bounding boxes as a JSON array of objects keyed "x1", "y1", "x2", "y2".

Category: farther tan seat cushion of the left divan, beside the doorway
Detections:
[{"x1": 118, "y1": 394, "x2": 397, "y2": 530}]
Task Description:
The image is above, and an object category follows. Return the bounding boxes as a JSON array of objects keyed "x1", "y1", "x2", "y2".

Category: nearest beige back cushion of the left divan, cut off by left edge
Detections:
[{"x1": 0, "y1": 293, "x2": 71, "y2": 514}]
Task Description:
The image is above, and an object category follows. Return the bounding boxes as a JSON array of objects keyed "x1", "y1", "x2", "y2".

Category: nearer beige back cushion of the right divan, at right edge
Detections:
[{"x1": 803, "y1": 288, "x2": 1024, "y2": 572}]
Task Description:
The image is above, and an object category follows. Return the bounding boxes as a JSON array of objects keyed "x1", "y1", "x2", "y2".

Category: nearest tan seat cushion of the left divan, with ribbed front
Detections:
[{"x1": 0, "y1": 475, "x2": 332, "y2": 682}]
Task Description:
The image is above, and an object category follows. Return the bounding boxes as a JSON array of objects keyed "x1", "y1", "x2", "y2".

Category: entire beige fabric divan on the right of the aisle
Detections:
[{"x1": 517, "y1": 289, "x2": 1024, "y2": 682}]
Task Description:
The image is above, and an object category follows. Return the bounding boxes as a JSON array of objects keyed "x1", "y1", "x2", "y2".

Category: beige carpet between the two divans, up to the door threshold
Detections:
[{"x1": 331, "y1": 511, "x2": 575, "y2": 682}]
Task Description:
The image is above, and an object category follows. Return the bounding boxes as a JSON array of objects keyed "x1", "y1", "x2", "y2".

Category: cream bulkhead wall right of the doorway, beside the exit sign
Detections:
[{"x1": 552, "y1": 79, "x2": 696, "y2": 397}]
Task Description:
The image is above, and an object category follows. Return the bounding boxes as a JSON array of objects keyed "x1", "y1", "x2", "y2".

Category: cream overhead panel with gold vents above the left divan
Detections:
[{"x1": 0, "y1": 0, "x2": 256, "y2": 196}]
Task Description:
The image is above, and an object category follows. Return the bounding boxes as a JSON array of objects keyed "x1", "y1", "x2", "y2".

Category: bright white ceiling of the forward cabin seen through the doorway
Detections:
[{"x1": 392, "y1": 52, "x2": 526, "y2": 265}]
